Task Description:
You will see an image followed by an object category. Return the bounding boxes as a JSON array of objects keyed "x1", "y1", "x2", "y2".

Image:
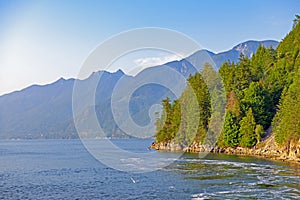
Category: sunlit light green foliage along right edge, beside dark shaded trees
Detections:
[{"x1": 269, "y1": 15, "x2": 300, "y2": 145}]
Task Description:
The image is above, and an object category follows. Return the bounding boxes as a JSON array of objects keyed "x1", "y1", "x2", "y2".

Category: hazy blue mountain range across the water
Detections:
[{"x1": 0, "y1": 40, "x2": 278, "y2": 139}]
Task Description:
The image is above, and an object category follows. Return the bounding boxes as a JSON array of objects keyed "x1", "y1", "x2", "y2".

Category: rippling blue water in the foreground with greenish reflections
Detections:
[{"x1": 0, "y1": 140, "x2": 300, "y2": 199}]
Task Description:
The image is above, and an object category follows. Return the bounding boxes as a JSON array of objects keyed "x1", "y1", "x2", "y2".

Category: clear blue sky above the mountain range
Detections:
[{"x1": 0, "y1": 0, "x2": 300, "y2": 95}]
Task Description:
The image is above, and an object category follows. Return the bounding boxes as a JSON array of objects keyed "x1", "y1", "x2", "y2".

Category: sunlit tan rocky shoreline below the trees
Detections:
[{"x1": 150, "y1": 136, "x2": 300, "y2": 166}]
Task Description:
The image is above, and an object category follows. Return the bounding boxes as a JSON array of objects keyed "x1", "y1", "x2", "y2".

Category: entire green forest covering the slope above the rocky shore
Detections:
[{"x1": 157, "y1": 16, "x2": 300, "y2": 147}]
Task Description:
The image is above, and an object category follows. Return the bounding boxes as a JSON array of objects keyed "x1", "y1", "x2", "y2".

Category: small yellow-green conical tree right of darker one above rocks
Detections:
[{"x1": 239, "y1": 108, "x2": 257, "y2": 147}]
